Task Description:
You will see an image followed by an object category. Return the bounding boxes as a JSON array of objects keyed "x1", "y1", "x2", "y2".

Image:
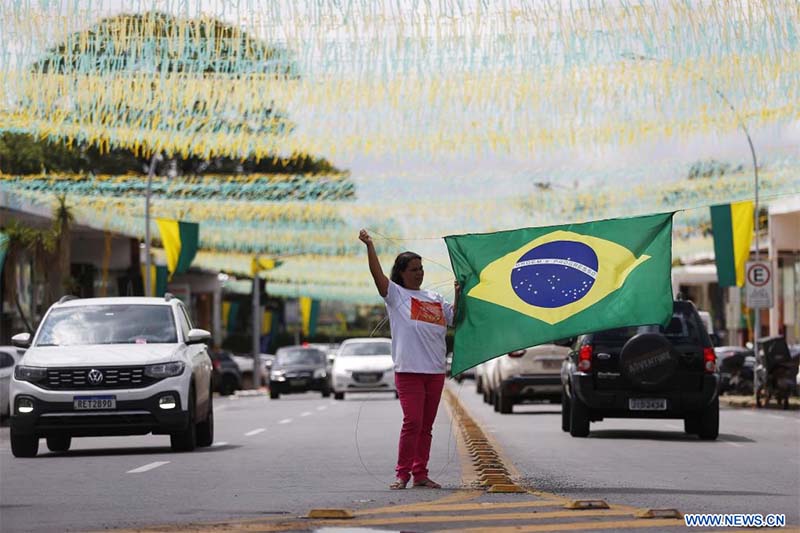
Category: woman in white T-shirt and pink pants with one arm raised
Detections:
[{"x1": 358, "y1": 229, "x2": 460, "y2": 489}]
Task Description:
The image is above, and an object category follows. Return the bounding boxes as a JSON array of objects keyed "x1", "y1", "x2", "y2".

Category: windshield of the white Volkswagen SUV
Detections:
[{"x1": 36, "y1": 304, "x2": 178, "y2": 346}]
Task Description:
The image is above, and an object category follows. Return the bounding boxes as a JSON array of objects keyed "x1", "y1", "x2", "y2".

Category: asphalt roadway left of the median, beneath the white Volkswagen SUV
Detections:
[{"x1": 0, "y1": 393, "x2": 461, "y2": 532}]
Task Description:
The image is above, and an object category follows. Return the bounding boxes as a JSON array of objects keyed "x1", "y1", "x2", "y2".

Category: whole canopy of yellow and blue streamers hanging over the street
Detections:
[{"x1": 0, "y1": 0, "x2": 800, "y2": 303}]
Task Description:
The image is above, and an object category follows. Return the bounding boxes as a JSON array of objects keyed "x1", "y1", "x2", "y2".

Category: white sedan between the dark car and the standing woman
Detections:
[{"x1": 332, "y1": 337, "x2": 397, "y2": 400}]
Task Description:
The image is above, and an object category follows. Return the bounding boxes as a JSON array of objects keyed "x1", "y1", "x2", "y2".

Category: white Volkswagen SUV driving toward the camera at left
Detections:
[{"x1": 10, "y1": 294, "x2": 214, "y2": 457}]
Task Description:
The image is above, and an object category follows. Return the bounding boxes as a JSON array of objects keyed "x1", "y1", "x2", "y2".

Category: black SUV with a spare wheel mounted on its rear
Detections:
[{"x1": 561, "y1": 300, "x2": 719, "y2": 440}]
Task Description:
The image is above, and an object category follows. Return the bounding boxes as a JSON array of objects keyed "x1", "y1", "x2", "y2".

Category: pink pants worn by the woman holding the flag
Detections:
[{"x1": 394, "y1": 372, "x2": 444, "y2": 481}]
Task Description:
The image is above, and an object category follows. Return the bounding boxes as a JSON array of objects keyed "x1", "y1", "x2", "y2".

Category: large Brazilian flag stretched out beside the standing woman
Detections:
[{"x1": 445, "y1": 213, "x2": 674, "y2": 374}]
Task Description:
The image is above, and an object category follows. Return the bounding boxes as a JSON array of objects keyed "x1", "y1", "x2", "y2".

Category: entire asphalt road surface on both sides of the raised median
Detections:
[{"x1": 0, "y1": 381, "x2": 800, "y2": 533}]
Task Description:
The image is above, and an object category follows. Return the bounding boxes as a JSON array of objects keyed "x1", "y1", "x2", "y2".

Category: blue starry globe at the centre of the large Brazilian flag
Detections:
[{"x1": 511, "y1": 241, "x2": 598, "y2": 309}]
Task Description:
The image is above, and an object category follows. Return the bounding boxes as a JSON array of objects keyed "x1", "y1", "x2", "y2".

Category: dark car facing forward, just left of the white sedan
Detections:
[{"x1": 269, "y1": 346, "x2": 331, "y2": 400}]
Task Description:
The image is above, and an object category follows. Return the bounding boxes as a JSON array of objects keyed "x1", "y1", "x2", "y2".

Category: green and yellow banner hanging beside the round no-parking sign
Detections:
[{"x1": 711, "y1": 201, "x2": 755, "y2": 287}]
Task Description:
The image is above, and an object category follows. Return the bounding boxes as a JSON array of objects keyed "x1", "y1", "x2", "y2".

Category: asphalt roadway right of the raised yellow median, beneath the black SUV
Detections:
[{"x1": 450, "y1": 381, "x2": 800, "y2": 524}]
